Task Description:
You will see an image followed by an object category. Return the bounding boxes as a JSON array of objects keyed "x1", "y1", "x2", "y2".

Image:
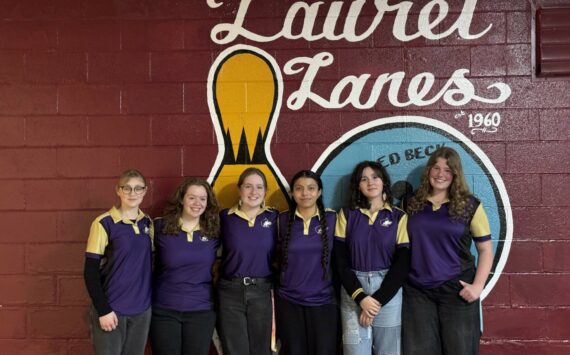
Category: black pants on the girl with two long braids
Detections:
[{"x1": 275, "y1": 295, "x2": 339, "y2": 355}]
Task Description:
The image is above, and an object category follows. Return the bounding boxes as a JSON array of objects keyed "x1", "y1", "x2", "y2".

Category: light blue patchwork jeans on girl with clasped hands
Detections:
[{"x1": 340, "y1": 270, "x2": 402, "y2": 355}]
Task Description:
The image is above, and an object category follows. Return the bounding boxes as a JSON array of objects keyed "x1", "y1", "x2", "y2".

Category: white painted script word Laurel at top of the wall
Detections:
[{"x1": 207, "y1": 0, "x2": 492, "y2": 44}]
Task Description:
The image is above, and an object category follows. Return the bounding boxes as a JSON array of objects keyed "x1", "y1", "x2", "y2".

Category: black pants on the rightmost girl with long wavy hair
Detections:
[{"x1": 402, "y1": 278, "x2": 481, "y2": 355}]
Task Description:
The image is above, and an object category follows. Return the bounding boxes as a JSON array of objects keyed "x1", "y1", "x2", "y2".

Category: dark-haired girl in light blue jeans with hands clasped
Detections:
[{"x1": 334, "y1": 161, "x2": 409, "y2": 355}]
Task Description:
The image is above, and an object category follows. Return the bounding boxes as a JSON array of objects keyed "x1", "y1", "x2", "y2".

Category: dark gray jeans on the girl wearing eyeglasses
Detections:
[{"x1": 90, "y1": 306, "x2": 151, "y2": 355}]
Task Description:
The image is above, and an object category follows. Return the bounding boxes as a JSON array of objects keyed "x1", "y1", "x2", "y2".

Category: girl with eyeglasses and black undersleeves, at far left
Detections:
[{"x1": 84, "y1": 169, "x2": 153, "y2": 355}]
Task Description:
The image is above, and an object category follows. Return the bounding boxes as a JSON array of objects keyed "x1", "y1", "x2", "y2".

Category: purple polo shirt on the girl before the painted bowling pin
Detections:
[{"x1": 220, "y1": 206, "x2": 277, "y2": 279}]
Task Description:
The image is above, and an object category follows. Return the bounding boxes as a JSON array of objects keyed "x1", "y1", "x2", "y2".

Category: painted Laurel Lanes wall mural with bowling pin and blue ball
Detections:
[{"x1": 207, "y1": 0, "x2": 513, "y2": 299}]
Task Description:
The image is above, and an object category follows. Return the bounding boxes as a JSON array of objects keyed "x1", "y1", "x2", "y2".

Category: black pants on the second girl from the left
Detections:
[{"x1": 150, "y1": 307, "x2": 216, "y2": 355}]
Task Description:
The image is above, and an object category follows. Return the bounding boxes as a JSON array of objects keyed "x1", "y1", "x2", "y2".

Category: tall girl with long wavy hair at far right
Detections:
[{"x1": 402, "y1": 147, "x2": 493, "y2": 355}]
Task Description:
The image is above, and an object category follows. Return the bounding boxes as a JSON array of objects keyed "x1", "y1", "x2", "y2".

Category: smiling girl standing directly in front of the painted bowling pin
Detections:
[{"x1": 217, "y1": 168, "x2": 277, "y2": 355}]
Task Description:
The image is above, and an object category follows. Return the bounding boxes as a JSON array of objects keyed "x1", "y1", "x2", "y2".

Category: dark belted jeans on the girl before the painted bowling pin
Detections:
[{"x1": 217, "y1": 279, "x2": 272, "y2": 355}]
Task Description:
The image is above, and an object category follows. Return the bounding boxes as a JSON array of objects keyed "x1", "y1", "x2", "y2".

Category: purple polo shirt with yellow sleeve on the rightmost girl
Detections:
[{"x1": 408, "y1": 197, "x2": 491, "y2": 288}]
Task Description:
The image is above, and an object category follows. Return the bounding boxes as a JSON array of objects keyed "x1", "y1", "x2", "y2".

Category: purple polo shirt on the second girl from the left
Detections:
[{"x1": 153, "y1": 219, "x2": 219, "y2": 312}]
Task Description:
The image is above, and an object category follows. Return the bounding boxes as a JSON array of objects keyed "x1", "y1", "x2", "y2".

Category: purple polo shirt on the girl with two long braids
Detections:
[{"x1": 278, "y1": 211, "x2": 336, "y2": 306}]
